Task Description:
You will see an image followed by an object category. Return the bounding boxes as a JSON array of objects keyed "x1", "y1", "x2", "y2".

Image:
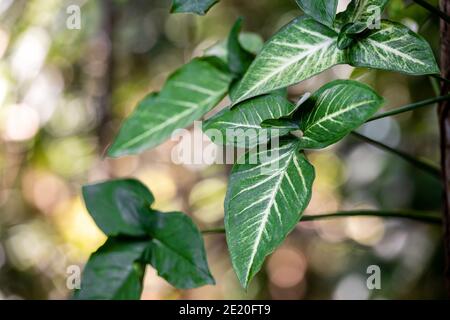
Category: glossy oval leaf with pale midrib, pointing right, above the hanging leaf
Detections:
[{"x1": 300, "y1": 80, "x2": 383, "y2": 149}]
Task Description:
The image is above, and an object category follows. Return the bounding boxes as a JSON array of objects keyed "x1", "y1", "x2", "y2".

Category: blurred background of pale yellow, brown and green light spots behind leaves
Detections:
[{"x1": 0, "y1": 0, "x2": 445, "y2": 299}]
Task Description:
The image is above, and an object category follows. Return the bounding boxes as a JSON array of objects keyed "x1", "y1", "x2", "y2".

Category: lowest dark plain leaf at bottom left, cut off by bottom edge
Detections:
[{"x1": 74, "y1": 238, "x2": 148, "y2": 300}]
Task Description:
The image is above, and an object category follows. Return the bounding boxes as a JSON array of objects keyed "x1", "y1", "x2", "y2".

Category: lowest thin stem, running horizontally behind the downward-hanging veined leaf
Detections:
[{"x1": 202, "y1": 210, "x2": 442, "y2": 234}]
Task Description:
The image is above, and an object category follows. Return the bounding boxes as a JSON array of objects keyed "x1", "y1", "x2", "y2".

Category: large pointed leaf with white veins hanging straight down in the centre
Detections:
[{"x1": 225, "y1": 140, "x2": 315, "y2": 287}]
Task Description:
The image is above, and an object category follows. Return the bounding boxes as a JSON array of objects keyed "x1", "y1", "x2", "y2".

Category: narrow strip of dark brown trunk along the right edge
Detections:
[{"x1": 438, "y1": 0, "x2": 450, "y2": 297}]
